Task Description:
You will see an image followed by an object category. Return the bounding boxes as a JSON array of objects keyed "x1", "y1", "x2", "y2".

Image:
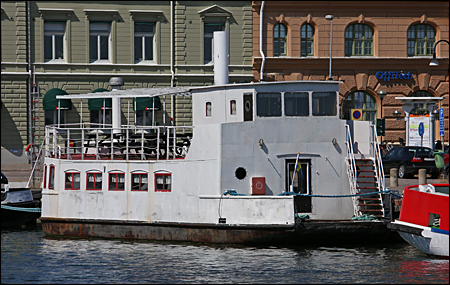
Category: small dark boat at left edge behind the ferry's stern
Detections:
[{"x1": 1, "y1": 173, "x2": 41, "y2": 229}]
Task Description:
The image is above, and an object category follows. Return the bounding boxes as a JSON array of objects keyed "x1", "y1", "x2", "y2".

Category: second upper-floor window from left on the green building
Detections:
[{"x1": 89, "y1": 22, "x2": 111, "y2": 63}]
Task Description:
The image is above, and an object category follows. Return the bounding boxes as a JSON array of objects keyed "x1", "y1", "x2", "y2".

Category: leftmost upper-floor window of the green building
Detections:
[{"x1": 44, "y1": 22, "x2": 66, "y2": 62}]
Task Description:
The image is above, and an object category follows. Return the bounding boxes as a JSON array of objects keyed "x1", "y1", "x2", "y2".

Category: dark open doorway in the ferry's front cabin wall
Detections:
[{"x1": 285, "y1": 159, "x2": 312, "y2": 213}]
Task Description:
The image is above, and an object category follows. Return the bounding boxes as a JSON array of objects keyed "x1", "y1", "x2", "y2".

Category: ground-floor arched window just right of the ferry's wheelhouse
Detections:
[{"x1": 342, "y1": 91, "x2": 377, "y2": 121}]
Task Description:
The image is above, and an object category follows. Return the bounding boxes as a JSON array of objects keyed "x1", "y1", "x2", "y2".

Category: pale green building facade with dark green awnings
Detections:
[{"x1": 1, "y1": 1, "x2": 253, "y2": 167}]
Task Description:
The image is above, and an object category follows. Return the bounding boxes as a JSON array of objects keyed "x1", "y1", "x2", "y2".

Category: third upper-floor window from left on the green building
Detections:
[{"x1": 134, "y1": 22, "x2": 155, "y2": 63}]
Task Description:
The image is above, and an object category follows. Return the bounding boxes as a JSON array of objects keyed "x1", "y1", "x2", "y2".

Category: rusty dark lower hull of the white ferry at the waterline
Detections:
[{"x1": 40, "y1": 218, "x2": 404, "y2": 245}]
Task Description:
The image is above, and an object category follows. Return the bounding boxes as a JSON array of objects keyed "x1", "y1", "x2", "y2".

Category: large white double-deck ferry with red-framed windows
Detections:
[{"x1": 37, "y1": 31, "x2": 396, "y2": 244}]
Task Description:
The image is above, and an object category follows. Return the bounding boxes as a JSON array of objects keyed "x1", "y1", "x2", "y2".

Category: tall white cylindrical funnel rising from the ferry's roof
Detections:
[{"x1": 214, "y1": 31, "x2": 229, "y2": 85}]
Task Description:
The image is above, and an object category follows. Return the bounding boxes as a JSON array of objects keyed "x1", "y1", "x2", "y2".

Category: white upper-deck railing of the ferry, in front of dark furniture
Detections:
[{"x1": 45, "y1": 123, "x2": 193, "y2": 160}]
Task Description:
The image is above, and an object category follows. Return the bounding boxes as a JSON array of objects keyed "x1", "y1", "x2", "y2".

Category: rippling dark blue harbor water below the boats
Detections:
[{"x1": 1, "y1": 225, "x2": 449, "y2": 284}]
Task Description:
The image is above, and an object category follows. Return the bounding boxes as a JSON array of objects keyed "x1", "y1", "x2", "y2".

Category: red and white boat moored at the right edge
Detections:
[{"x1": 388, "y1": 183, "x2": 449, "y2": 258}]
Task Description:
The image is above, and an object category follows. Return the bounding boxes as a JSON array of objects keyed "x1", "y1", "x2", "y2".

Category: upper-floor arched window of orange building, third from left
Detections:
[{"x1": 345, "y1": 24, "x2": 373, "y2": 56}]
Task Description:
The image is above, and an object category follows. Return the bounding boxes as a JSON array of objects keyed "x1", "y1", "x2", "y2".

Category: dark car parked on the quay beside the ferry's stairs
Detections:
[{"x1": 381, "y1": 146, "x2": 440, "y2": 178}]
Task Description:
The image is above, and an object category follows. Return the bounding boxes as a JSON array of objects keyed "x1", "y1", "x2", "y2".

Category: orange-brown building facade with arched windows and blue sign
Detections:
[{"x1": 252, "y1": 1, "x2": 449, "y2": 145}]
